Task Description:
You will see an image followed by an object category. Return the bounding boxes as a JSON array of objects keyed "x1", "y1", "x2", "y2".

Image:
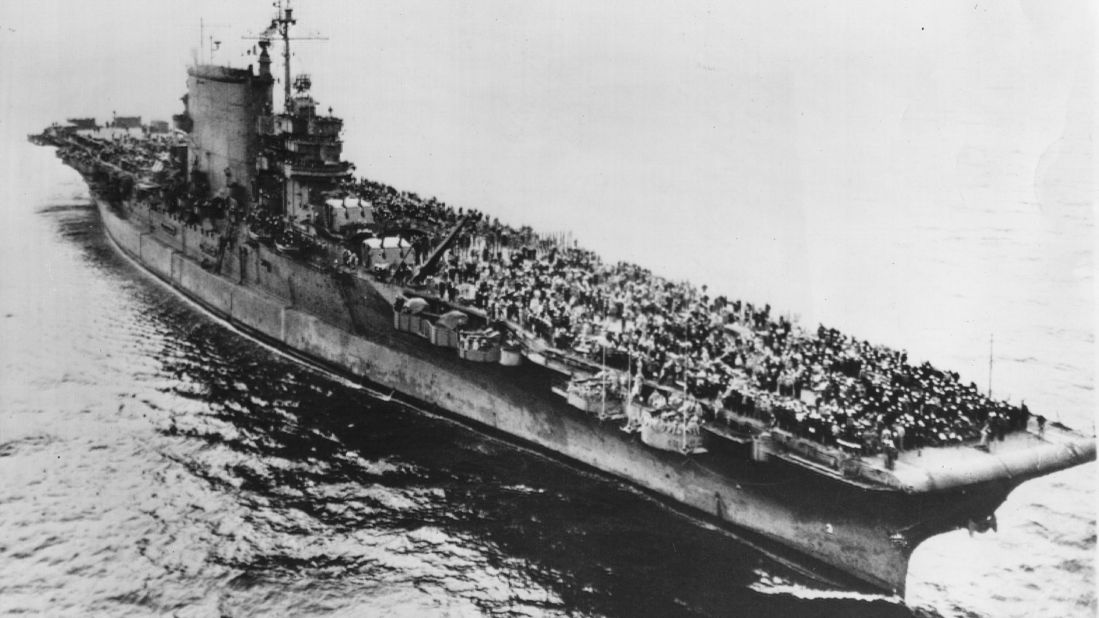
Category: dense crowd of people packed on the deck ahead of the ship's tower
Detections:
[{"x1": 345, "y1": 175, "x2": 1030, "y2": 455}]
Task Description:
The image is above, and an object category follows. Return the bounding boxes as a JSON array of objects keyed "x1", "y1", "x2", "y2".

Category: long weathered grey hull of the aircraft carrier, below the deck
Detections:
[{"x1": 90, "y1": 191, "x2": 1023, "y2": 595}]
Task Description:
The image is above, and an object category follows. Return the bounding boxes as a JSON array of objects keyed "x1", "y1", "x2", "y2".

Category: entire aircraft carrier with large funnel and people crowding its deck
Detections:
[{"x1": 31, "y1": 2, "x2": 1095, "y2": 594}]
